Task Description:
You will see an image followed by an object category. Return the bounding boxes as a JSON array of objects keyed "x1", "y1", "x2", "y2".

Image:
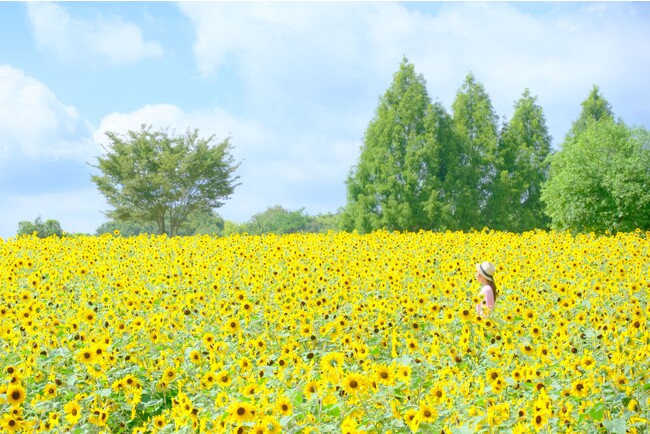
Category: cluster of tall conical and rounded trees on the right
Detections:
[{"x1": 342, "y1": 58, "x2": 650, "y2": 233}]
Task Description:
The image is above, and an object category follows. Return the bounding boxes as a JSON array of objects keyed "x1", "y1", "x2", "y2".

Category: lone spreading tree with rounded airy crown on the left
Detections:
[{"x1": 91, "y1": 125, "x2": 239, "y2": 235}]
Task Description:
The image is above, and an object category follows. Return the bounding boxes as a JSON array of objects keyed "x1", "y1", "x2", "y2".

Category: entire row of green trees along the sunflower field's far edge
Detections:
[{"x1": 12, "y1": 57, "x2": 650, "y2": 236}]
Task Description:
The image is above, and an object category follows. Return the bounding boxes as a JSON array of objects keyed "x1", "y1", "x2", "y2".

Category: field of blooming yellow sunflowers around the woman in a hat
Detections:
[{"x1": 0, "y1": 230, "x2": 650, "y2": 434}]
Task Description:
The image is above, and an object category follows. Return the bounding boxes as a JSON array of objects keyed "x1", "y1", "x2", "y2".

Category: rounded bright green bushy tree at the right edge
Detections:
[{"x1": 542, "y1": 114, "x2": 650, "y2": 233}]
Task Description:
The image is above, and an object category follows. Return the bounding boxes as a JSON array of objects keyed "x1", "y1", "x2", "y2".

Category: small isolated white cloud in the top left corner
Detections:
[{"x1": 27, "y1": 2, "x2": 163, "y2": 65}]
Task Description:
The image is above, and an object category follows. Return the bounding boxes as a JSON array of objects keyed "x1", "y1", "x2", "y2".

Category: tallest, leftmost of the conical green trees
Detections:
[{"x1": 342, "y1": 58, "x2": 453, "y2": 233}]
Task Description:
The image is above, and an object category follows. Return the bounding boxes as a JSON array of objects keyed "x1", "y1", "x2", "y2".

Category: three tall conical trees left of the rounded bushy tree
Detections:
[{"x1": 342, "y1": 59, "x2": 556, "y2": 233}]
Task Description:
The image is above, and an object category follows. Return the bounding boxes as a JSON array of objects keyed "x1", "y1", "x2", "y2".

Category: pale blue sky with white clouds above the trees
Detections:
[{"x1": 0, "y1": 2, "x2": 650, "y2": 239}]
